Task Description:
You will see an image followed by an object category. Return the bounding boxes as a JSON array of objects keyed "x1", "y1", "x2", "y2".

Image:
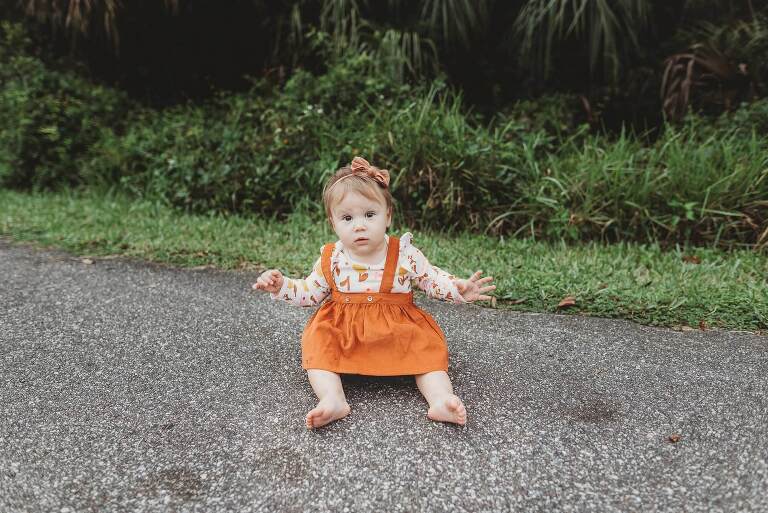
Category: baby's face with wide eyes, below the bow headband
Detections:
[{"x1": 331, "y1": 191, "x2": 392, "y2": 263}]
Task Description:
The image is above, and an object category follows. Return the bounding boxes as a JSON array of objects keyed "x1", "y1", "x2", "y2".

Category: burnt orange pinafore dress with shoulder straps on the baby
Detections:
[{"x1": 301, "y1": 237, "x2": 448, "y2": 376}]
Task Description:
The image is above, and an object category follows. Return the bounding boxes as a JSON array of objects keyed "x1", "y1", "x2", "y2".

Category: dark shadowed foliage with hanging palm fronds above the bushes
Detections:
[{"x1": 12, "y1": 0, "x2": 768, "y2": 120}]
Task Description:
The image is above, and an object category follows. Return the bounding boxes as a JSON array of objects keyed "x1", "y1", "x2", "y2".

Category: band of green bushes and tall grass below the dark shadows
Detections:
[{"x1": 0, "y1": 25, "x2": 768, "y2": 245}]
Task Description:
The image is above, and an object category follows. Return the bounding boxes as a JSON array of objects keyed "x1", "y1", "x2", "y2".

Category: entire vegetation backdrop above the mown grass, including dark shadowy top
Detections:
[{"x1": 0, "y1": 0, "x2": 768, "y2": 249}]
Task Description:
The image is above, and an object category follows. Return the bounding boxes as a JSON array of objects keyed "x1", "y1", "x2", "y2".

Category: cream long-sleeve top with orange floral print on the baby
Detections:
[{"x1": 270, "y1": 232, "x2": 466, "y2": 306}]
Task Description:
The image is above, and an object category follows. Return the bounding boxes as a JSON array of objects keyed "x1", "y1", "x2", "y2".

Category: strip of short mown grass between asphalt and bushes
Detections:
[{"x1": 0, "y1": 190, "x2": 768, "y2": 331}]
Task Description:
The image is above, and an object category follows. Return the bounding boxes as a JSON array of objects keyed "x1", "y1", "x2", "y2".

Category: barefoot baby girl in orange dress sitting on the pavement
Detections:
[{"x1": 253, "y1": 157, "x2": 496, "y2": 429}]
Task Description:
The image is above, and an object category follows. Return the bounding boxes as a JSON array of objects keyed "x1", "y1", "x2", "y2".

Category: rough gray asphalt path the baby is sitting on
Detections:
[{"x1": 0, "y1": 241, "x2": 768, "y2": 513}]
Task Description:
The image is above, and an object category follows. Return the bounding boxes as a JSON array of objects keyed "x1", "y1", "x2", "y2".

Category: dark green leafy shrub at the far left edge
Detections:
[{"x1": 0, "y1": 21, "x2": 126, "y2": 188}]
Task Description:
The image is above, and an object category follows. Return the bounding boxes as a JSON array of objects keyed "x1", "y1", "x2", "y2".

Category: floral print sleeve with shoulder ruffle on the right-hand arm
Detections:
[{"x1": 398, "y1": 232, "x2": 467, "y2": 303}]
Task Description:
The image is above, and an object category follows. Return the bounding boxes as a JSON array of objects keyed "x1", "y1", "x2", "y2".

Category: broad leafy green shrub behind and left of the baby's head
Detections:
[{"x1": 86, "y1": 54, "x2": 424, "y2": 214}]
